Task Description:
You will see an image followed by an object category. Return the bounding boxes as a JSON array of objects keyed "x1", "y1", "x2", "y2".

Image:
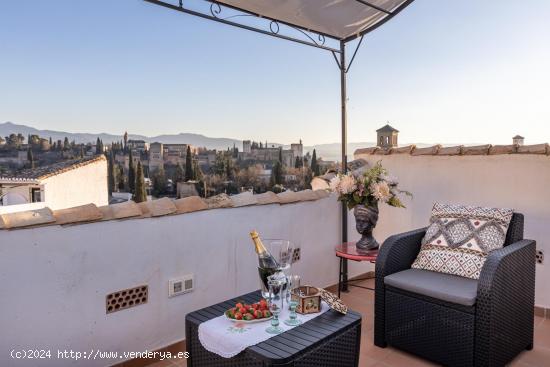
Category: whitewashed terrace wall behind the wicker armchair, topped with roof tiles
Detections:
[{"x1": 355, "y1": 154, "x2": 550, "y2": 307}]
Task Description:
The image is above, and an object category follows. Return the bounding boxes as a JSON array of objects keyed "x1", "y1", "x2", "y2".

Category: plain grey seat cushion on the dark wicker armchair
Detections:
[{"x1": 384, "y1": 269, "x2": 478, "y2": 306}]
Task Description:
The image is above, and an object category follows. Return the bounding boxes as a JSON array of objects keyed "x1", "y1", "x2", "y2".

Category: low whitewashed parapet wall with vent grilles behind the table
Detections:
[{"x1": 0, "y1": 197, "x2": 372, "y2": 367}]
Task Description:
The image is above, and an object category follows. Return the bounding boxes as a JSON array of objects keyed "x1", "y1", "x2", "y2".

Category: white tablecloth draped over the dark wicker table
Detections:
[{"x1": 199, "y1": 302, "x2": 330, "y2": 358}]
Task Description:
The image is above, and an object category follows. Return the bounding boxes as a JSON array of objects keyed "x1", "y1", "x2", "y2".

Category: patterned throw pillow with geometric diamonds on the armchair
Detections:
[{"x1": 412, "y1": 203, "x2": 513, "y2": 279}]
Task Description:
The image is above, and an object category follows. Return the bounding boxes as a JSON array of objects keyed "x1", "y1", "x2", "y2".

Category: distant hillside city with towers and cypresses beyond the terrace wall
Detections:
[{"x1": 0, "y1": 129, "x2": 335, "y2": 205}]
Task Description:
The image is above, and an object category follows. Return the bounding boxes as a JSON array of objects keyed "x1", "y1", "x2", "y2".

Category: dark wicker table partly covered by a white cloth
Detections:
[{"x1": 185, "y1": 291, "x2": 361, "y2": 367}]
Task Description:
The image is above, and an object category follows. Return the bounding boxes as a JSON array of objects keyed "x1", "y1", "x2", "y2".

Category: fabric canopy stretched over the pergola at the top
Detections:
[{"x1": 217, "y1": 0, "x2": 412, "y2": 40}]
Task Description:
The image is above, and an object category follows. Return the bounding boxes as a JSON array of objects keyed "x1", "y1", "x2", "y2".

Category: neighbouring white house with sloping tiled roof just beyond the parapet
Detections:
[{"x1": 0, "y1": 155, "x2": 109, "y2": 210}]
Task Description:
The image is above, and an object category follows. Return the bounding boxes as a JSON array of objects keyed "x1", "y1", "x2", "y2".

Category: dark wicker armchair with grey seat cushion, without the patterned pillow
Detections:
[{"x1": 374, "y1": 213, "x2": 535, "y2": 366}]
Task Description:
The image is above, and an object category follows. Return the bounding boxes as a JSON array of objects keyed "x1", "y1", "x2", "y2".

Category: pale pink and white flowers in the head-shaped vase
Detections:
[{"x1": 330, "y1": 162, "x2": 412, "y2": 210}]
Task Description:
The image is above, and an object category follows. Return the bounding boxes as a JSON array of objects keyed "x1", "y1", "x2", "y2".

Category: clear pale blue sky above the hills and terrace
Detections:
[{"x1": 0, "y1": 0, "x2": 550, "y2": 145}]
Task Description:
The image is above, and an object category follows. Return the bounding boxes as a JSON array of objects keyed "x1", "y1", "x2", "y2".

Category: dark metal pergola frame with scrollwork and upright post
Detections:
[{"x1": 144, "y1": 0, "x2": 414, "y2": 291}]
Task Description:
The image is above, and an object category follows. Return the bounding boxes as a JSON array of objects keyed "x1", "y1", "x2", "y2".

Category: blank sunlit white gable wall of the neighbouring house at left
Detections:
[{"x1": 42, "y1": 160, "x2": 109, "y2": 210}]
